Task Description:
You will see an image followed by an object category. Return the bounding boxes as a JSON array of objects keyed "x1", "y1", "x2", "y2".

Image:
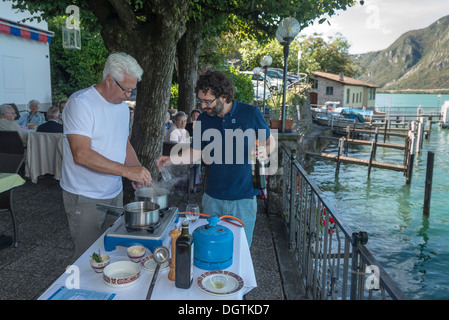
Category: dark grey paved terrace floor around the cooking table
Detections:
[{"x1": 0, "y1": 175, "x2": 304, "y2": 300}]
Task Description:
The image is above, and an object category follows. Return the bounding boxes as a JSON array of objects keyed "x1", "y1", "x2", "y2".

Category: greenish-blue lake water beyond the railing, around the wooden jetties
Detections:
[{"x1": 310, "y1": 94, "x2": 449, "y2": 299}]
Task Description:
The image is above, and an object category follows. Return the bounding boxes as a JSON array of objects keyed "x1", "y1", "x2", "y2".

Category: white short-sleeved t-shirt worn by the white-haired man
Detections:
[{"x1": 60, "y1": 86, "x2": 129, "y2": 199}]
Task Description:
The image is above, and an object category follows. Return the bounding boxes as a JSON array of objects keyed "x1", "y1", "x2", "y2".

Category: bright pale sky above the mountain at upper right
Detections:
[{"x1": 300, "y1": 0, "x2": 449, "y2": 54}]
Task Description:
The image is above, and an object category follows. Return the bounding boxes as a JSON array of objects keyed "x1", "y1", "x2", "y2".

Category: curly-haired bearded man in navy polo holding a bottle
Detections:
[{"x1": 158, "y1": 71, "x2": 275, "y2": 246}]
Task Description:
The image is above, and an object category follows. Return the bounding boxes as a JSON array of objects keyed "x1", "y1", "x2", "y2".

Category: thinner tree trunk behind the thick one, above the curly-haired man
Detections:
[{"x1": 177, "y1": 19, "x2": 203, "y2": 116}]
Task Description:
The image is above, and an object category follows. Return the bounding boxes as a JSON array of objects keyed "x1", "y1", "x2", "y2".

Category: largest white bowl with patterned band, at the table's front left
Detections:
[{"x1": 103, "y1": 261, "x2": 140, "y2": 288}]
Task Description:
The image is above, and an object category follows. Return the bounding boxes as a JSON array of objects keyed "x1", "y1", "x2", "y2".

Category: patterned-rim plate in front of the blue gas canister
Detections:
[{"x1": 196, "y1": 270, "x2": 244, "y2": 296}]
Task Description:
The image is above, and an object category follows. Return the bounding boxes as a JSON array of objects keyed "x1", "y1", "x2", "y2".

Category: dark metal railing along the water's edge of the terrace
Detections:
[{"x1": 279, "y1": 144, "x2": 407, "y2": 300}]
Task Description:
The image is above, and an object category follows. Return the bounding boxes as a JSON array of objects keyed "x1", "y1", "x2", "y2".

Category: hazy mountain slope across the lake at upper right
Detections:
[{"x1": 354, "y1": 16, "x2": 449, "y2": 90}]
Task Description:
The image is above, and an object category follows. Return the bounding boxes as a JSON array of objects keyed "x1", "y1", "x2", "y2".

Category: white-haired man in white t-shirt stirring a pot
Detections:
[{"x1": 61, "y1": 53, "x2": 152, "y2": 257}]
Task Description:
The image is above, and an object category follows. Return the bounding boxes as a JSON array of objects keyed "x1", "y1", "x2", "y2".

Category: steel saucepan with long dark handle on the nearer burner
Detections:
[{"x1": 97, "y1": 201, "x2": 159, "y2": 228}]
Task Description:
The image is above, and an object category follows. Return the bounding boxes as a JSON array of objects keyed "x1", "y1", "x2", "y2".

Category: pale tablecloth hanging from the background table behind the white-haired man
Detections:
[{"x1": 25, "y1": 132, "x2": 64, "y2": 183}]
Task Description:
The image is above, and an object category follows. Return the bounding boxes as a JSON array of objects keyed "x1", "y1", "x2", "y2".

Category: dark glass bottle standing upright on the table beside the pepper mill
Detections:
[{"x1": 175, "y1": 221, "x2": 193, "y2": 289}]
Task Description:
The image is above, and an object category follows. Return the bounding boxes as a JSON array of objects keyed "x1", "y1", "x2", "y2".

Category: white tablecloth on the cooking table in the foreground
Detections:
[{"x1": 39, "y1": 216, "x2": 257, "y2": 300}]
